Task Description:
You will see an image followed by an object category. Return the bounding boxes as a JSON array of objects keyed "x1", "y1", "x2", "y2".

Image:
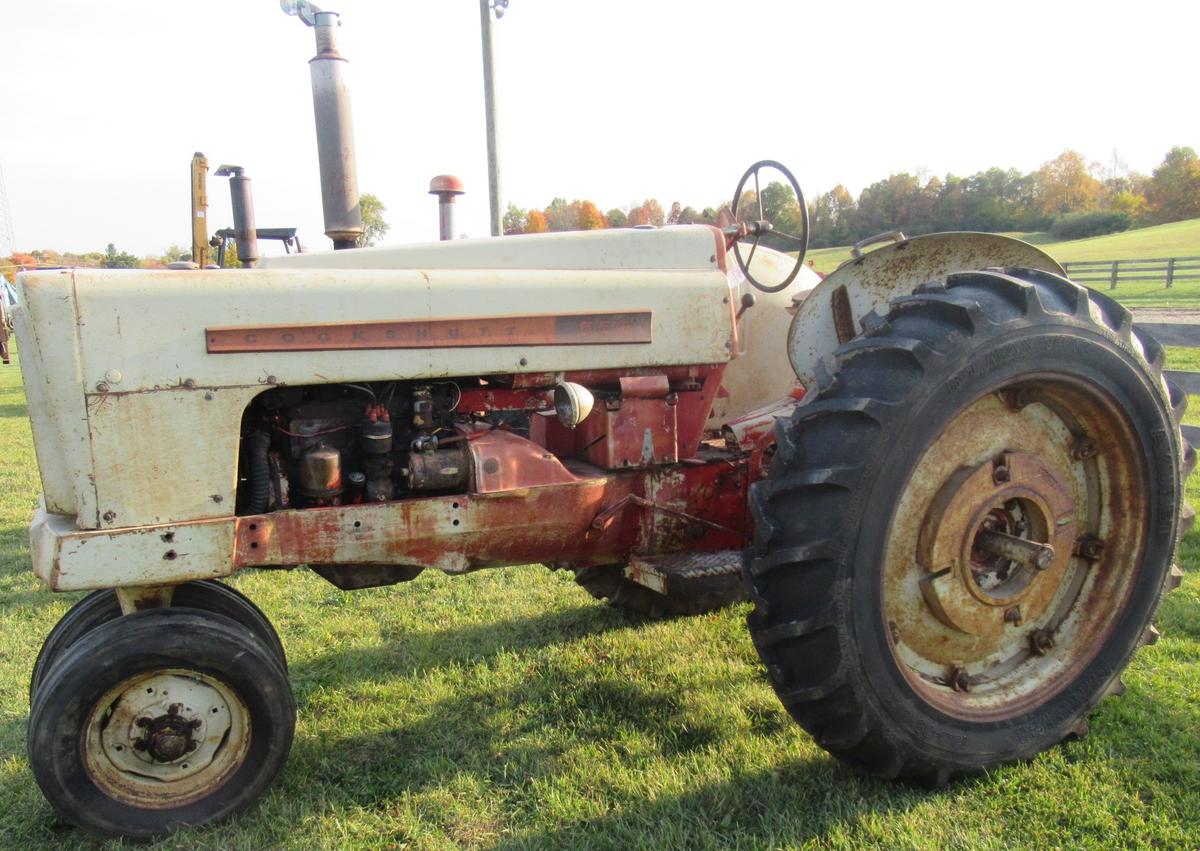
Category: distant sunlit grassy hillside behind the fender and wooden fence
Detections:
[{"x1": 808, "y1": 218, "x2": 1200, "y2": 307}]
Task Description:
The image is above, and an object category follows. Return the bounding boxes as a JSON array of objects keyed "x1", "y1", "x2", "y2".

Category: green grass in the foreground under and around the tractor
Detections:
[{"x1": 0, "y1": 350, "x2": 1200, "y2": 850}]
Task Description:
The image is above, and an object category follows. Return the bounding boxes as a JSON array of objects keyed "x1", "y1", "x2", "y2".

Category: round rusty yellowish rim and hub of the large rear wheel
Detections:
[{"x1": 882, "y1": 377, "x2": 1146, "y2": 719}]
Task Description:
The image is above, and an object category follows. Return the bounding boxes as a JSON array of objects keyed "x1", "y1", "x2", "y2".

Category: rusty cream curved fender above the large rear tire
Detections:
[{"x1": 787, "y1": 232, "x2": 1066, "y2": 398}]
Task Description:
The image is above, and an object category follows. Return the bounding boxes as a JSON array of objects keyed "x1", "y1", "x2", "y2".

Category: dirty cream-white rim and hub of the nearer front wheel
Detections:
[{"x1": 85, "y1": 670, "x2": 250, "y2": 809}]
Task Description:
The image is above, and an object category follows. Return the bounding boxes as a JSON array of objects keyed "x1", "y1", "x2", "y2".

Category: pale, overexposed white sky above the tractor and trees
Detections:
[{"x1": 0, "y1": 0, "x2": 1200, "y2": 254}]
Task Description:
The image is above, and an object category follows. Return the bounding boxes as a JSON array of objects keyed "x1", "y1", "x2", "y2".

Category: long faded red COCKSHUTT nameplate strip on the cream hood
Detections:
[{"x1": 205, "y1": 311, "x2": 652, "y2": 354}]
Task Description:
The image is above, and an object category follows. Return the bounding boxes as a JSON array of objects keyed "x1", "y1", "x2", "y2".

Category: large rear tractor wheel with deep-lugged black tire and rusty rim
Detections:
[{"x1": 745, "y1": 269, "x2": 1195, "y2": 784}]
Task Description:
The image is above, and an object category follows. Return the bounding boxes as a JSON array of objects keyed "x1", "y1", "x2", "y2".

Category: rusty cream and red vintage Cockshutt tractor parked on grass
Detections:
[{"x1": 13, "y1": 13, "x2": 1195, "y2": 838}]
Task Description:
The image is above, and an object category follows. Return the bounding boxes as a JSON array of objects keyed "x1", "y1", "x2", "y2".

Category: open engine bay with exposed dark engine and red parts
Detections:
[{"x1": 236, "y1": 366, "x2": 720, "y2": 515}]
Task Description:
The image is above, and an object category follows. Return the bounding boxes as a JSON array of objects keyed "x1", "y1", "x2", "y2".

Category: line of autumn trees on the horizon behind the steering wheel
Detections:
[{"x1": 504, "y1": 146, "x2": 1200, "y2": 247}]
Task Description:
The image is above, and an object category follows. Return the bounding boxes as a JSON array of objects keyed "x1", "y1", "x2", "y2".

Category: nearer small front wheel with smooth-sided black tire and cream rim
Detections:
[{"x1": 28, "y1": 609, "x2": 295, "y2": 840}]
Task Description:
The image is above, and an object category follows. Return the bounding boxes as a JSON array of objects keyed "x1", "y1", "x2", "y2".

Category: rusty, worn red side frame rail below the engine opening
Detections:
[{"x1": 234, "y1": 457, "x2": 750, "y2": 573}]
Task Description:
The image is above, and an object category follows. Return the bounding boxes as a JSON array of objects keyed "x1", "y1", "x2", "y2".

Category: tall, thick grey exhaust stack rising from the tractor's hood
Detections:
[{"x1": 280, "y1": 0, "x2": 362, "y2": 248}]
